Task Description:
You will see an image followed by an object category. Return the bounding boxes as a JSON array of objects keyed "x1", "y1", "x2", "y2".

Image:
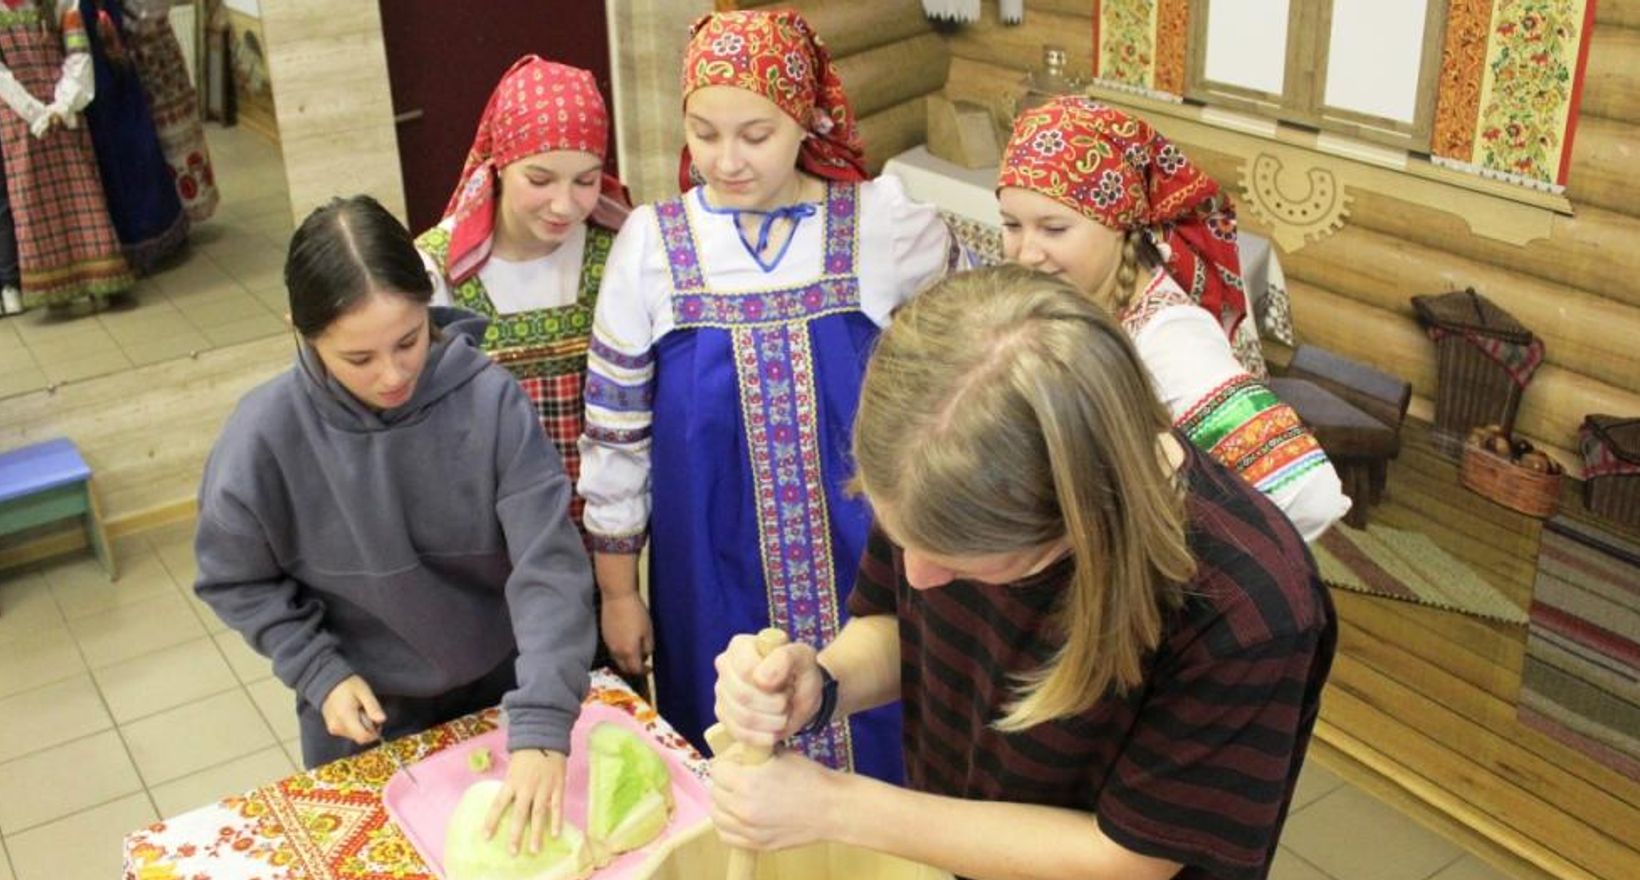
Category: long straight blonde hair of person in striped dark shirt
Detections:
[{"x1": 854, "y1": 265, "x2": 1196, "y2": 731}]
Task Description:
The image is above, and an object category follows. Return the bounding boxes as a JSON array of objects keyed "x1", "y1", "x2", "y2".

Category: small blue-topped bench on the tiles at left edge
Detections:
[{"x1": 0, "y1": 438, "x2": 120, "y2": 580}]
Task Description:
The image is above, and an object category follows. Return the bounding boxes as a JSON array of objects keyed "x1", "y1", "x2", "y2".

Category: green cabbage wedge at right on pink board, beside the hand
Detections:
[{"x1": 587, "y1": 723, "x2": 672, "y2": 864}]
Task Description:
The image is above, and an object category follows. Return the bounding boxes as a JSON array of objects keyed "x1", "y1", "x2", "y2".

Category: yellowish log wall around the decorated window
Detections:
[{"x1": 950, "y1": 0, "x2": 1640, "y2": 460}]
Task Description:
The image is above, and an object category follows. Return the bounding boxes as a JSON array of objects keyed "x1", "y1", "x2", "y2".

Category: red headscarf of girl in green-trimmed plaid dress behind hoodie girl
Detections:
[{"x1": 444, "y1": 56, "x2": 630, "y2": 284}]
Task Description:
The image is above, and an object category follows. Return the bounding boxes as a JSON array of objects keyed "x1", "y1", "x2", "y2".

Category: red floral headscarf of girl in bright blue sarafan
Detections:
[{"x1": 677, "y1": 10, "x2": 866, "y2": 190}]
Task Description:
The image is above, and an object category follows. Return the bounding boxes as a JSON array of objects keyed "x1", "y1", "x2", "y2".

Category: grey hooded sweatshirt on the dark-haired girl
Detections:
[{"x1": 194, "y1": 308, "x2": 595, "y2": 754}]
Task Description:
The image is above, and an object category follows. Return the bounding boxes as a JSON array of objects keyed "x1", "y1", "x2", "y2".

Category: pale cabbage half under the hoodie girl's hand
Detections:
[{"x1": 444, "y1": 778, "x2": 592, "y2": 880}]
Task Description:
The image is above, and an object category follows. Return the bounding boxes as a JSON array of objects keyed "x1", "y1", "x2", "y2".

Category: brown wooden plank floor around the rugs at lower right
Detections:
[{"x1": 1314, "y1": 421, "x2": 1640, "y2": 880}]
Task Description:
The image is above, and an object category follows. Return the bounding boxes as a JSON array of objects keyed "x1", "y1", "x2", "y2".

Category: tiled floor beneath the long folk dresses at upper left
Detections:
[{"x1": 0, "y1": 125, "x2": 290, "y2": 399}]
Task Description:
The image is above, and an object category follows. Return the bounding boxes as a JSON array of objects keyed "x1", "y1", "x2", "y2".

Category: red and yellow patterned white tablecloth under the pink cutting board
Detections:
[{"x1": 125, "y1": 670, "x2": 707, "y2": 880}]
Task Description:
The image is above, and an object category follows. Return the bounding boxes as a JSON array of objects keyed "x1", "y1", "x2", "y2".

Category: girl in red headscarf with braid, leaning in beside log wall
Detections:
[{"x1": 997, "y1": 97, "x2": 1350, "y2": 541}]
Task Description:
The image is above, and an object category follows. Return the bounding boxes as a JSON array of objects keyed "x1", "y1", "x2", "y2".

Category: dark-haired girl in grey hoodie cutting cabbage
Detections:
[{"x1": 194, "y1": 197, "x2": 595, "y2": 849}]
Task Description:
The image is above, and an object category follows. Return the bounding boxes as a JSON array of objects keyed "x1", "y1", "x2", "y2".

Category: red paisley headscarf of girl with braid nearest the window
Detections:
[{"x1": 997, "y1": 95, "x2": 1246, "y2": 336}]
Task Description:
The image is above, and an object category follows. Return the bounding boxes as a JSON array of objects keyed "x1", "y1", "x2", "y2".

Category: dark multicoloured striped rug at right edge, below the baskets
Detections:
[{"x1": 1519, "y1": 516, "x2": 1640, "y2": 780}]
